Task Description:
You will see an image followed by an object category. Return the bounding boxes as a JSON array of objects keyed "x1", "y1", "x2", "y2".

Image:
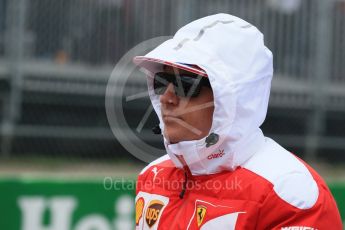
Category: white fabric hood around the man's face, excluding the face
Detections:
[{"x1": 137, "y1": 14, "x2": 273, "y2": 175}]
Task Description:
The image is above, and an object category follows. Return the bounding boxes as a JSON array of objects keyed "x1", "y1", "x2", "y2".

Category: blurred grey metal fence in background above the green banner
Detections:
[{"x1": 0, "y1": 0, "x2": 345, "y2": 162}]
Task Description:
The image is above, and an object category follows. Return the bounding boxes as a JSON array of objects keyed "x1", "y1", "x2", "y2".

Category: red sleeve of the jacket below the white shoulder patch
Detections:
[{"x1": 256, "y1": 184, "x2": 343, "y2": 230}]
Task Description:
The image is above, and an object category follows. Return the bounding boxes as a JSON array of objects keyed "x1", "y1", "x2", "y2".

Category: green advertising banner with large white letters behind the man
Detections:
[{"x1": 0, "y1": 177, "x2": 345, "y2": 230}]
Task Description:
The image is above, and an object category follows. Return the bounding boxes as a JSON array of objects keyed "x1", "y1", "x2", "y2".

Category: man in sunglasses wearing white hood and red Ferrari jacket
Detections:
[{"x1": 134, "y1": 14, "x2": 342, "y2": 230}]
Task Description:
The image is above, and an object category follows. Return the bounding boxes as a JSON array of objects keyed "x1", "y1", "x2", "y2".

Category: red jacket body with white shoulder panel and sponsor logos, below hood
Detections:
[{"x1": 135, "y1": 140, "x2": 342, "y2": 230}]
